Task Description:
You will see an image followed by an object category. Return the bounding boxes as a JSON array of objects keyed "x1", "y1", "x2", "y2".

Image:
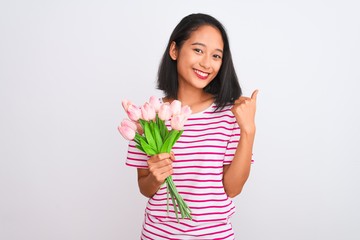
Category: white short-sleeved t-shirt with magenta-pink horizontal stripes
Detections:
[{"x1": 126, "y1": 104, "x2": 240, "y2": 240}]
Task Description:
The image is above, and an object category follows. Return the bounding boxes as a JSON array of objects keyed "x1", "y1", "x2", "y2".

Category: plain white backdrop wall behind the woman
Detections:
[{"x1": 0, "y1": 0, "x2": 360, "y2": 240}]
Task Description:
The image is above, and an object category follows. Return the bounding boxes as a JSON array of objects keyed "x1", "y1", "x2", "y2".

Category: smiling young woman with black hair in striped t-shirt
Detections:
[{"x1": 126, "y1": 14, "x2": 258, "y2": 239}]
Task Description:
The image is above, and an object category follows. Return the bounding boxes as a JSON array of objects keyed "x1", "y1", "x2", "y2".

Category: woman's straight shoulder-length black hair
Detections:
[{"x1": 157, "y1": 13, "x2": 242, "y2": 109}]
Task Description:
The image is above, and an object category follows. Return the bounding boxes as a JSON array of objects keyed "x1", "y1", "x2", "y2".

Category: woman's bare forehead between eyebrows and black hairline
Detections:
[{"x1": 186, "y1": 25, "x2": 224, "y2": 49}]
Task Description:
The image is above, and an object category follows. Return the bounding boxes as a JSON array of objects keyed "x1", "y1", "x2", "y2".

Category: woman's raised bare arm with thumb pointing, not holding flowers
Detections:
[{"x1": 223, "y1": 90, "x2": 258, "y2": 198}]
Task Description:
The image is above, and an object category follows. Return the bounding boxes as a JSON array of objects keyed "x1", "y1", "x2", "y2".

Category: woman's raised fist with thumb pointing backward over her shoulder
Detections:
[{"x1": 231, "y1": 90, "x2": 259, "y2": 134}]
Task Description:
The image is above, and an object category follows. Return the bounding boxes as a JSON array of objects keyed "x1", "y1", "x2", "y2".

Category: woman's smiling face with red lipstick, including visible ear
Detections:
[{"x1": 170, "y1": 25, "x2": 224, "y2": 92}]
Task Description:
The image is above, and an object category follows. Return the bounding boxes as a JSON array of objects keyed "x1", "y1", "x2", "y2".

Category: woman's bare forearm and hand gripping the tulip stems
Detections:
[{"x1": 137, "y1": 153, "x2": 174, "y2": 198}]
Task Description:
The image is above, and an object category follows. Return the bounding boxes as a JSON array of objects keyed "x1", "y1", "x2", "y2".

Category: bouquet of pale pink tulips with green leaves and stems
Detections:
[{"x1": 118, "y1": 96, "x2": 192, "y2": 222}]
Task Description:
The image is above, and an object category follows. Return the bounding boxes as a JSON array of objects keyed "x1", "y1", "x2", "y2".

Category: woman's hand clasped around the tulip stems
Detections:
[{"x1": 147, "y1": 152, "x2": 175, "y2": 185}]
